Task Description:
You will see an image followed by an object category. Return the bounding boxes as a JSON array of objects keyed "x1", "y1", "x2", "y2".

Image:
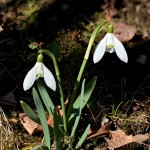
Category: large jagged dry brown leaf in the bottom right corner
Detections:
[{"x1": 105, "y1": 130, "x2": 149, "y2": 149}]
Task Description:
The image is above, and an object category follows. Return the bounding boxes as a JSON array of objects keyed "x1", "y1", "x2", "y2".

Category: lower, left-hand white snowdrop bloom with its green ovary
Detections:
[{"x1": 23, "y1": 54, "x2": 56, "y2": 91}]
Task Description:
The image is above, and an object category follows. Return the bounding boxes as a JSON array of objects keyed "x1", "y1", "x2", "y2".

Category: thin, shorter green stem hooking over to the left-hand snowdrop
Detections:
[{"x1": 38, "y1": 49, "x2": 67, "y2": 134}]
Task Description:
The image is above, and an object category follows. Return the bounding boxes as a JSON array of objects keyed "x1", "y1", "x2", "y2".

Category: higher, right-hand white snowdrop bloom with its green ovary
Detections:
[{"x1": 93, "y1": 25, "x2": 128, "y2": 63}]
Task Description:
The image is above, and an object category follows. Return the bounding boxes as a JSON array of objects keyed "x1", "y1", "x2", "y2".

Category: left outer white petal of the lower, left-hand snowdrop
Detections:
[{"x1": 23, "y1": 63, "x2": 37, "y2": 91}]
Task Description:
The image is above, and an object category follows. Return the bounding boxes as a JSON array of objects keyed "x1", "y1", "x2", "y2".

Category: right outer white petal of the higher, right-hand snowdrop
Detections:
[{"x1": 113, "y1": 36, "x2": 128, "y2": 63}]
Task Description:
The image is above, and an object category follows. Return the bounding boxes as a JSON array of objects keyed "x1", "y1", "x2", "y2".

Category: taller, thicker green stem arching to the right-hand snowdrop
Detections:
[{"x1": 67, "y1": 20, "x2": 110, "y2": 121}]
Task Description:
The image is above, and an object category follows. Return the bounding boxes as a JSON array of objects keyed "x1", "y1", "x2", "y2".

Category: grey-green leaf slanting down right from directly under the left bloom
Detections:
[{"x1": 37, "y1": 79, "x2": 55, "y2": 118}]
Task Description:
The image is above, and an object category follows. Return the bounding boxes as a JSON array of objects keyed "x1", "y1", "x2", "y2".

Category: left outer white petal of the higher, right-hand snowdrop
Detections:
[{"x1": 93, "y1": 34, "x2": 109, "y2": 63}]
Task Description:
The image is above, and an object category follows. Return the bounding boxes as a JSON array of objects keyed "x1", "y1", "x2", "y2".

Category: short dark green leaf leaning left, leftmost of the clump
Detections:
[{"x1": 20, "y1": 101, "x2": 41, "y2": 124}]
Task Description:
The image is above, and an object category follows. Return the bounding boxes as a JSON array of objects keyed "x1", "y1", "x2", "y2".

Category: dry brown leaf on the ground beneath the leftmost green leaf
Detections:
[{"x1": 19, "y1": 113, "x2": 42, "y2": 135}]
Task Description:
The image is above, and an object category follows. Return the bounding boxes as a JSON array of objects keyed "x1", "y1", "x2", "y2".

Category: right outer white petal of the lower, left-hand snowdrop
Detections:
[{"x1": 43, "y1": 64, "x2": 56, "y2": 91}]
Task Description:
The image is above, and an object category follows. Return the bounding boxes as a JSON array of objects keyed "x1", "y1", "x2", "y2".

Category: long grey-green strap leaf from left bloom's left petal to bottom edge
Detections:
[{"x1": 32, "y1": 88, "x2": 51, "y2": 149}]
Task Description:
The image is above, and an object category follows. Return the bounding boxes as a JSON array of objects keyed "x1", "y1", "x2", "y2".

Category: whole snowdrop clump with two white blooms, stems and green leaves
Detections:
[{"x1": 20, "y1": 20, "x2": 128, "y2": 150}]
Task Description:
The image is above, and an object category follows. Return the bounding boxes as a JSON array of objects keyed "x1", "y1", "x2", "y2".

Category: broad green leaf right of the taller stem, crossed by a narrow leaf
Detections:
[{"x1": 69, "y1": 77, "x2": 97, "y2": 122}]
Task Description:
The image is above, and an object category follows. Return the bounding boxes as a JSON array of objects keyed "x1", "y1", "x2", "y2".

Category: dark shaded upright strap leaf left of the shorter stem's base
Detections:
[{"x1": 53, "y1": 109, "x2": 61, "y2": 150}]
